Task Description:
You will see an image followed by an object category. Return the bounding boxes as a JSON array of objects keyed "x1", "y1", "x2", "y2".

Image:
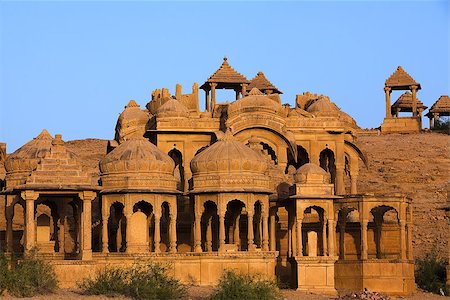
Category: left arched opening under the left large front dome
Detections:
[{"x1": 108, "y1": 202, "x2": 126, "y2": 252}]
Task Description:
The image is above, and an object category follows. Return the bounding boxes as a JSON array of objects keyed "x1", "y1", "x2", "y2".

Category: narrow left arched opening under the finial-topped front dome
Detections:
[{"x1": 201, "y1": 201, "x2": 219, "y2": 252}]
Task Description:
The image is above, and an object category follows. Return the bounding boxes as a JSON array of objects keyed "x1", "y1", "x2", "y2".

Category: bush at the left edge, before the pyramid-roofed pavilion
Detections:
[{"x1": 0, "y1": 253, "x2": 58, "y2": 297}]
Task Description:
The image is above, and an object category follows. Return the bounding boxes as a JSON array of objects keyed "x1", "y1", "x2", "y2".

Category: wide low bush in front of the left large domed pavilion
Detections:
[{"x1": 78, "y1": 263, "x2": 186, "y2": 299}]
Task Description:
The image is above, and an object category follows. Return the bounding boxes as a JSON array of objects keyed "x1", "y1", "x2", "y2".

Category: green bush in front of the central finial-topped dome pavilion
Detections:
[{"x1": 211, "y1": 271, "x2": 282, "y2": 300}]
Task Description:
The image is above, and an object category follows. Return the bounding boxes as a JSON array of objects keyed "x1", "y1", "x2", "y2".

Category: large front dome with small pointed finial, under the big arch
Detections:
[{"x1": 191, "y1": 131, "x2": 269, "y2": 191}]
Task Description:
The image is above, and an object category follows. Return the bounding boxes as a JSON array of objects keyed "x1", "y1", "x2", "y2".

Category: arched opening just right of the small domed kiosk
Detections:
[{"x1": 336, "y1": 207, "x2": 361, "y2": 260}]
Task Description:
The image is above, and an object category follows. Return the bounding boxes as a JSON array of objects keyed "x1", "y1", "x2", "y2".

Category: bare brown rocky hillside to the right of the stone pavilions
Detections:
[{"x1": 357, "y1": 133, "x2": 450, "y2": 257}]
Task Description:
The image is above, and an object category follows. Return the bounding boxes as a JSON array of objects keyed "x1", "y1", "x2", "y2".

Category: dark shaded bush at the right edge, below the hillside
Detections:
[{"x1": 415, "y1": 251, "x2": 450, "y2": 296}]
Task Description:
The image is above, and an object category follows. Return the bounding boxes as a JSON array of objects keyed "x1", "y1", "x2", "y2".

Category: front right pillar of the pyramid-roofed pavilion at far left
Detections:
[{"x1": 80, "y1": 192, "x2": 94, "y2": 260}]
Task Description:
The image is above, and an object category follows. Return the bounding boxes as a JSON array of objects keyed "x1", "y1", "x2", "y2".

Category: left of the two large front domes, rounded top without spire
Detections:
[{"x1": 99, "y1": 137, "x2": 177, "y2": 191}]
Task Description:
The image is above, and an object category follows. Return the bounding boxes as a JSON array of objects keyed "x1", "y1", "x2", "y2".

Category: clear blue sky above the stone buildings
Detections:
[{"x1": 0, "y1": 1, "x2": 449, "y2": 153}]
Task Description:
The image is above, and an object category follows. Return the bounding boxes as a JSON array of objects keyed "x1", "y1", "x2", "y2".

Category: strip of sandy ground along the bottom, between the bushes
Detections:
[{"x1": 0, "y1": 286, "x2": 450, "y2": 300}]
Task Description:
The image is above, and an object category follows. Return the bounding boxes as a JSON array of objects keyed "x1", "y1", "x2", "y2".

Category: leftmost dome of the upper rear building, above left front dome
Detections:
[{"x1": 115, "y1": 100, "x2": 150, "y2": 143}]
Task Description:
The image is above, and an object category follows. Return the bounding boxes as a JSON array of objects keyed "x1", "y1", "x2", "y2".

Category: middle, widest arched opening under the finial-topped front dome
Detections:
[{"x1": 225, "y1": 200, "x2": 246, "y2": 251}]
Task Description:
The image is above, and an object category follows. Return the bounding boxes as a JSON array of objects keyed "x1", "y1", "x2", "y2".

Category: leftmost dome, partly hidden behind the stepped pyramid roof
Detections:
[{"x1": 5, "y1": 129, "x2": 53, "y2": 187}]
